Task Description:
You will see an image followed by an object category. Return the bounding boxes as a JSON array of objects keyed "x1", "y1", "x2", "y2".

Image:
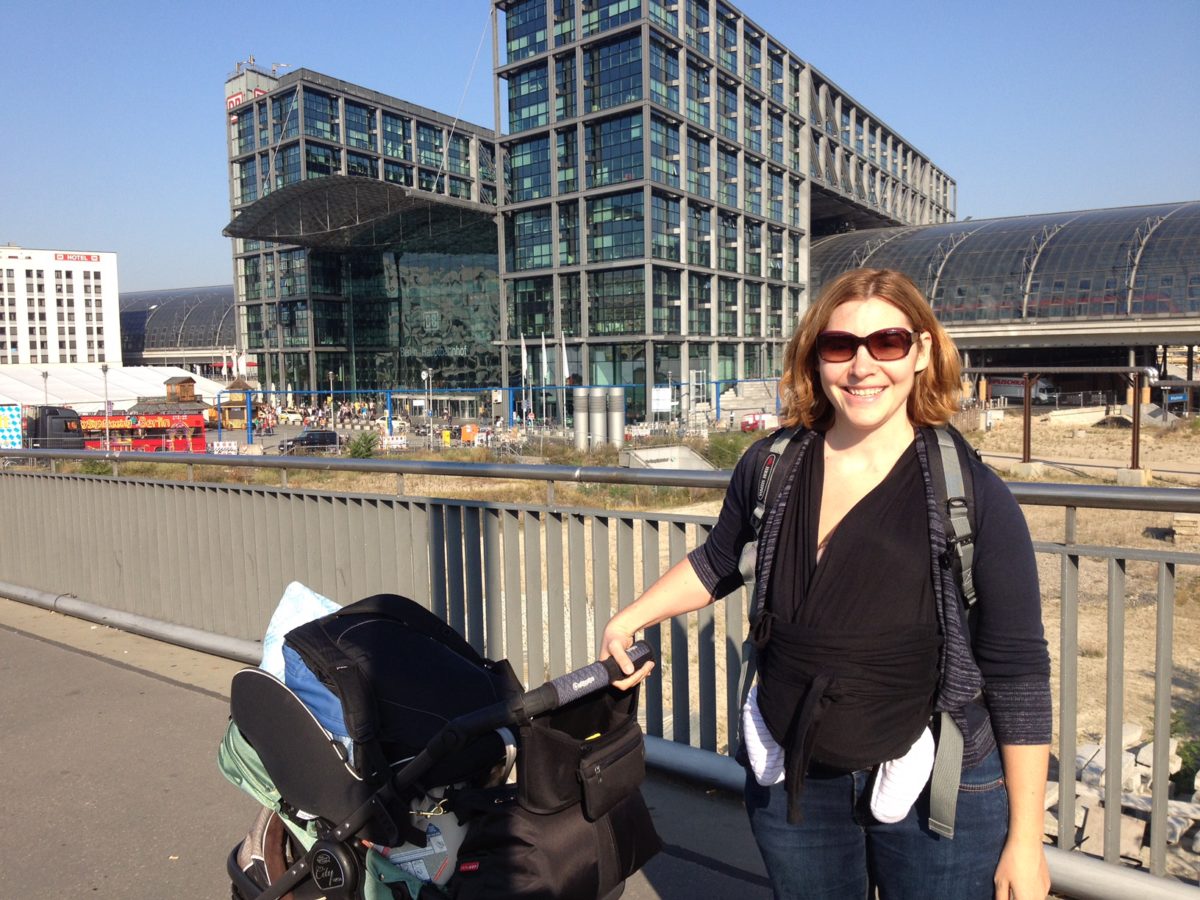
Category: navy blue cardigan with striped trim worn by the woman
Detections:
[{"x1": 688, "y1": 428, "x2": 1051, "y2": 767}]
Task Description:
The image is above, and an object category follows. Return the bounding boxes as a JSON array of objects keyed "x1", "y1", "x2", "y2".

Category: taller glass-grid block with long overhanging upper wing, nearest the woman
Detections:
[{"x1": 492, "y1": 0, "x2": 955, "y2": 414}]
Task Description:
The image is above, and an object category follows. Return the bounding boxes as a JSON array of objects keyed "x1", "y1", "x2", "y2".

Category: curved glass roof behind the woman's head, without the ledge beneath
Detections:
[{"x1": 811, "y1": 202, "x2": 1200, "y2": 323}]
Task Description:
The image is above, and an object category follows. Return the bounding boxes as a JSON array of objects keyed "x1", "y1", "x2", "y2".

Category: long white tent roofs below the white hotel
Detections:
[{"x1": 0, "y1": 362, "x2": 231, "y2": 413}]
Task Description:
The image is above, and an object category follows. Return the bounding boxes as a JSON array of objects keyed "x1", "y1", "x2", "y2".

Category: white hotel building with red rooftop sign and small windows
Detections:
[{"x1": 0, "y1": 245, "x2": 121, "y2": 365}]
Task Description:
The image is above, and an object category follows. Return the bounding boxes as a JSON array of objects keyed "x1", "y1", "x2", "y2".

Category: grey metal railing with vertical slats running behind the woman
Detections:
[{"x1": 0, "y1": 450, "x2": 1200, "y2": 898}]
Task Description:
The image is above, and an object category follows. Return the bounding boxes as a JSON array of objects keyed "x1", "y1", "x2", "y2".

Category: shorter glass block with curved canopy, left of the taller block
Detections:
[{"x1": 226, "y1": 61, "x2": 502, "y2": 390}]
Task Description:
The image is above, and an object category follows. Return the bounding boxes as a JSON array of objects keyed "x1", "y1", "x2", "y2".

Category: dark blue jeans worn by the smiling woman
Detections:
[{"x1": 745, "y1": 750, "x2": 1008, "y2": 900}]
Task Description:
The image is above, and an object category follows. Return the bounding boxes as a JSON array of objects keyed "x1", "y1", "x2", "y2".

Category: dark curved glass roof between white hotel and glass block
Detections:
[{"x1": 120, "y1": 284, "x2": 236, "y2": 354}]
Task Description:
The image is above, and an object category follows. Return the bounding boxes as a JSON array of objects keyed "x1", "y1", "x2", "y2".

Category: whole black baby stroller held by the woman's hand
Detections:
[{"x1": 218, "y1": 594, "x2": 661, "y2": 900}]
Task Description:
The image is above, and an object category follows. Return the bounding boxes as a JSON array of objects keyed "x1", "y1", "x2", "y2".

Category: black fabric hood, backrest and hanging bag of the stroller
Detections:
[{"x1": 227, "y1": 594, "x2": 661, "y2": 900}]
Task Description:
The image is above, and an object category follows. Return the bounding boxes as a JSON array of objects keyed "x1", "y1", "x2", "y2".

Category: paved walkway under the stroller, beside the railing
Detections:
[{"x1": 0, "y1": 599, "x2": 770, "y2": 900}]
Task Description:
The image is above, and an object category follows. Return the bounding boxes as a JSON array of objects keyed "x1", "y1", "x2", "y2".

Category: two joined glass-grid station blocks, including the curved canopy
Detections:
[{"x1": 226, "y1": 0, "x2": 955, "y2": 414}]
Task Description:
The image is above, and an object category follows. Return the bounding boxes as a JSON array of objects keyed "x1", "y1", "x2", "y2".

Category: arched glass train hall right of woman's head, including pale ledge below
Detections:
[{"x1": 812, "y1": 200, "x2": 1200, "y2": 380}]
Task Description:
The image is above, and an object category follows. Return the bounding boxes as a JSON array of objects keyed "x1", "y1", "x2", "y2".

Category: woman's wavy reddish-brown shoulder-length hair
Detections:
[{"x1": 779, "y1": 269, "x2": 962, "y2": 431}]
